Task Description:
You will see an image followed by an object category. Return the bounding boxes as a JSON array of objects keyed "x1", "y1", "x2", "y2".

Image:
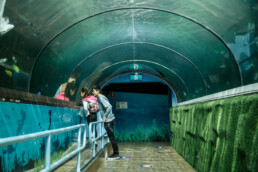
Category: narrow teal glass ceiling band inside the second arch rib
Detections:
[{"x1": 70, "y1": 43, "x2": 212, "y2": 102}]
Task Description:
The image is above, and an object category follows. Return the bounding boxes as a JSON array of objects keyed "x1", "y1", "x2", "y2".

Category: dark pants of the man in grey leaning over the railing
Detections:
[{"x1": 104, "y1": 120, "x2": 119, "y2": 155}]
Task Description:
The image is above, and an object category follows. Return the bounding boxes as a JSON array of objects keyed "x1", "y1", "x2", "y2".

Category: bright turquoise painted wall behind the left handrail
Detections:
[{"x1": 0, "y1": 102, "x2": 82, "y2": 172}]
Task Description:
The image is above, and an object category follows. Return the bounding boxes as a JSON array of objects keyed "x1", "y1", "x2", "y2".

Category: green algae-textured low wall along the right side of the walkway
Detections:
[{"x1": 170, "y1": 94, "x2": 258, "y2": 172}]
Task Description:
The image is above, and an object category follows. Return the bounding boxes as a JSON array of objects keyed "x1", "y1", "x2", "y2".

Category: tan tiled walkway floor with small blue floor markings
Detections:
[{"x1": 98, "y1": 142, "x2": 196, "y2": 172}]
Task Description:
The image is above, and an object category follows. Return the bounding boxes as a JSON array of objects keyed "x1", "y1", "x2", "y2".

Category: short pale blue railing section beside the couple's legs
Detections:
[{"x1": 89, "y1": 121, "x2": 109, "y2": 157}]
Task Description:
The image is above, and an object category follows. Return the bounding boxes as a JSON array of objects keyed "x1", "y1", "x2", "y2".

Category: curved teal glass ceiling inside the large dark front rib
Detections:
[{"x1": 31, "y1": 9, "x2": 241, "y2": 102}]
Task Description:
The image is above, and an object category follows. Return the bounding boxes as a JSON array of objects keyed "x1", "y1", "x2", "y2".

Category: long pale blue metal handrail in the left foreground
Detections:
[{"x1": 0, "y1": 124, "x2": 86, "y2": 172}]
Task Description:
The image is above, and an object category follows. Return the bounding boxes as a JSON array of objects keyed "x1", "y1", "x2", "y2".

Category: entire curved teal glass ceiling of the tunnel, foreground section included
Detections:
[{"x1": 0, "y1": 0, "x2": 257, "y2": 103}]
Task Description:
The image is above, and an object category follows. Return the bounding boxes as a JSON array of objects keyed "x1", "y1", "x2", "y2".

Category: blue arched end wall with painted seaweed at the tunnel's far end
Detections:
[{"x1": 94, "y1": 71, "x2": 173, "y2": 141}]
